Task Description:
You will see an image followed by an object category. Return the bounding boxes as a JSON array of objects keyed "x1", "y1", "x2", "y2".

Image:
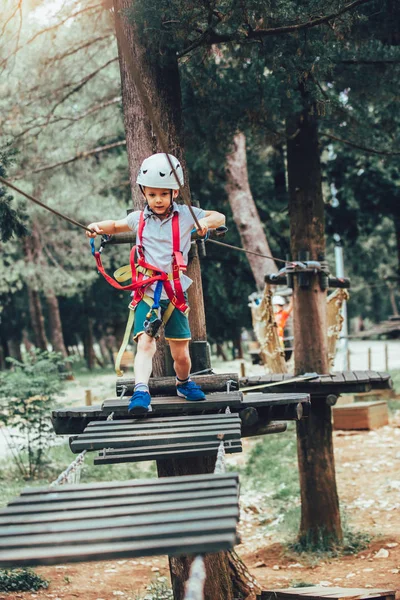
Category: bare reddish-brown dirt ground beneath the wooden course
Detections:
[{"x1": 0, "y1": 411, "x2": 400, "y2": 600}]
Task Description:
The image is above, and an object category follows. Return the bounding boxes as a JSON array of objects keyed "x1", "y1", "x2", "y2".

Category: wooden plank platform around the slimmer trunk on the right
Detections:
[{"x1": 240, "y1": 371, "x2": 393, "y2": 396}]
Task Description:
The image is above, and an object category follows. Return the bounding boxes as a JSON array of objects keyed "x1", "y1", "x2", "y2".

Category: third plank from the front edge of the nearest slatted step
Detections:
[{"x1": 0, "y1": 503, "x2": 239, "y2": 537}]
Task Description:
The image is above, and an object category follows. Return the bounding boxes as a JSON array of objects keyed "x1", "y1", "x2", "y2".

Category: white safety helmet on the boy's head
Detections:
[{"x1": 136, "y1": 152, "x2": 184, "y2": 190}]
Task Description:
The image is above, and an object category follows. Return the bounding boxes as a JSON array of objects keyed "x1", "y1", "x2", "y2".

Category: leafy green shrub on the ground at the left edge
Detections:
[{"x1": 0, "y1": 351, "x2": 66, "y2": 479}]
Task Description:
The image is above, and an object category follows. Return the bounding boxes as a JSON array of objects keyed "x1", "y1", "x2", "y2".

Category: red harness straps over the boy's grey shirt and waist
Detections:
[{"x1": 94, "y1": 211, "x2": 189, "y2": 312}]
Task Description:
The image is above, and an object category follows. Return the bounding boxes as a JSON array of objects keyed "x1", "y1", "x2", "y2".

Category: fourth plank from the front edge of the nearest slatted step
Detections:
[{"x1": 0, "y1": 494, "x2": 238, "y2": 527}]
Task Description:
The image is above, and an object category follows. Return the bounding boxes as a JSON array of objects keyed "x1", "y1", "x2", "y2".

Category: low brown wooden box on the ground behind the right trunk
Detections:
[{"x1": 333, "y1": 400, "x2": 389, "y2": 430}]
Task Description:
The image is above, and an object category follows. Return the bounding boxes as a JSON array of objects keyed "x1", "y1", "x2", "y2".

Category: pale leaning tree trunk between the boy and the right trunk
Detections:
[{"x1": 226, "y1": 133, "x2": 278, "y2": 290}]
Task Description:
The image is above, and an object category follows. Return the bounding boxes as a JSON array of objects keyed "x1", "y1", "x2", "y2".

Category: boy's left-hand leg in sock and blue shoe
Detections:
[{"x1": 128, "y1": 332, "x2": 156, "y2": 414}]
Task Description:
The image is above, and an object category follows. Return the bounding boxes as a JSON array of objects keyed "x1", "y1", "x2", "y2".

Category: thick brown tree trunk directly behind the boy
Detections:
[{"x1": 114, "y1": 0, "x2": 250, "y2": 600}]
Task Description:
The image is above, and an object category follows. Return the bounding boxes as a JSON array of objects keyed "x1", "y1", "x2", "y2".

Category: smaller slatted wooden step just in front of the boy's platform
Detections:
[{"x1": 70, "y1": 414, "x2": 242, "y2": 464}]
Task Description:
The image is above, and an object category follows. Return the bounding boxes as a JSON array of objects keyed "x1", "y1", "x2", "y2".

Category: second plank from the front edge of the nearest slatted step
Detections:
[{"x1": 0, "y1": 518, "x2": 237, "y2": 552}]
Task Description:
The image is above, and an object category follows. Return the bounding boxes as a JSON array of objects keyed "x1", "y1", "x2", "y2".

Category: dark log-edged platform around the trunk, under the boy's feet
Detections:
[{"x1": 51, "y1": 392, "x2": 310, "y2": 437}]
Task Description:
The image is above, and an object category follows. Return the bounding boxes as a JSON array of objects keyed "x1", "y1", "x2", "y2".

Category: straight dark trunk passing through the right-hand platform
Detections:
[{"x1": 287, "y1": 102, "x2": 342, "y2": 546}]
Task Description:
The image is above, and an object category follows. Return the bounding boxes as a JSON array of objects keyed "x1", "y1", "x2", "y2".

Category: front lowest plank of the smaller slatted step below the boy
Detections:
[{"x1": 94, "y1": 442, "x2": 242, "y2": 465}]
